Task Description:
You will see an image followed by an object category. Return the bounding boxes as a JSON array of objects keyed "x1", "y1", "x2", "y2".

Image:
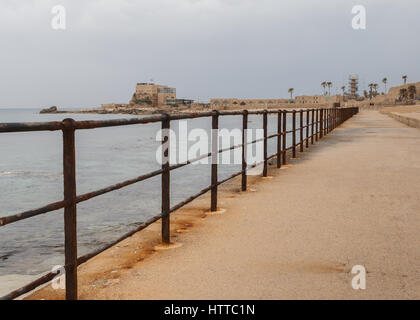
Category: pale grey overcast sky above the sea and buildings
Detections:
[{"x1": 0, "y1": 0, "x2": 420, "y2": 107}]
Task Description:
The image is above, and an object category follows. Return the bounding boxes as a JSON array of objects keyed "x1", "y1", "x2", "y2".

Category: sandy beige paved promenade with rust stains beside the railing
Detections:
[{"x1": 31, "y1": 111, "x2": 420, "y2": 299}]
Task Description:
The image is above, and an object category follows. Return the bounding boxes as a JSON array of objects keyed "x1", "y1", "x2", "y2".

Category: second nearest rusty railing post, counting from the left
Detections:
[{"x1": 162, "y1": 114, "x2": 171, "y2": 244}]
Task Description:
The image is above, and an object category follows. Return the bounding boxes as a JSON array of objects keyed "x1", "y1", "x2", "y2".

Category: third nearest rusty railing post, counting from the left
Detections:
[{"x1": 210, "y1": 110, "x2": 219, "y2": 212}]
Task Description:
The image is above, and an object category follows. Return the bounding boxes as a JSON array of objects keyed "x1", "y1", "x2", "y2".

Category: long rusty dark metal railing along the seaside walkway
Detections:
[{"x1": 0, "y1": 107, "x2": 358, "y2": 300}]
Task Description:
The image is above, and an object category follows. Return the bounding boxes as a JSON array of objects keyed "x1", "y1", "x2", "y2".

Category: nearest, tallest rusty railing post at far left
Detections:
[{"x1": 63, "y1": 119, "x2": 77, "y2": 300}]
